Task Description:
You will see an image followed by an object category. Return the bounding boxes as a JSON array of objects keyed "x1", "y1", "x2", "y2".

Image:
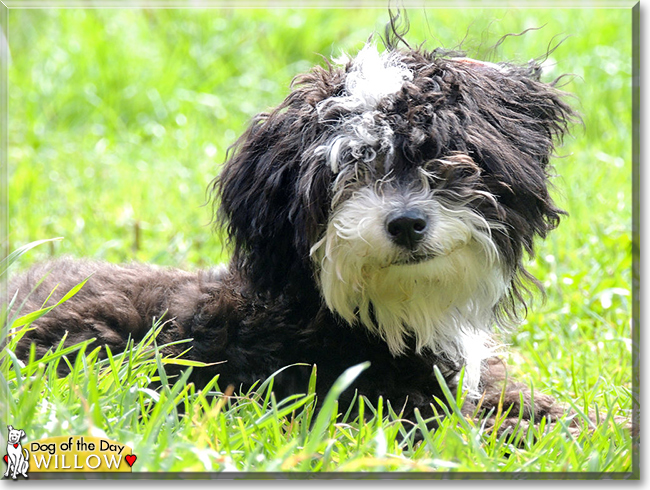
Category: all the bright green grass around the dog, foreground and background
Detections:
[{"x1": 0, "y1": 9, "x2": 636, "y2": 473}]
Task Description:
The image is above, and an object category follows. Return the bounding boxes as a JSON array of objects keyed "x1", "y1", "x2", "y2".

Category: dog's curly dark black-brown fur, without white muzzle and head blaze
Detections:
[{"x1": 10, "y1": 35, "x2": 573, "y2": 424}]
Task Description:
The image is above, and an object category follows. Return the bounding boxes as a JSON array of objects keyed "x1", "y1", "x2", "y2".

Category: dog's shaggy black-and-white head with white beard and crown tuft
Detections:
[{"x1": 214, "y1": 38, "x2": 572, "y2": 386}]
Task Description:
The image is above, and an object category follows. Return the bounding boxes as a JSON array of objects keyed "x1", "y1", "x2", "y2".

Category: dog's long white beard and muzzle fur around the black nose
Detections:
[{"x1": 312, "y1": 186, "x2": 507, "y2": 390}]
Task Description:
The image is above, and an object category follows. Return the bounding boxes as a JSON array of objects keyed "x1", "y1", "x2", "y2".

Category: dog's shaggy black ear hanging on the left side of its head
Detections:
[{"x1": 212, "y1": 67, "x2": 343, "y2": 291}]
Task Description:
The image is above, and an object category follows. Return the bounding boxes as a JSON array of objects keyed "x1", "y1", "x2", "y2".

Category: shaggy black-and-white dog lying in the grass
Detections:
[{"x1": 10, "y1": 26, "x2": 576, "y2": 432}]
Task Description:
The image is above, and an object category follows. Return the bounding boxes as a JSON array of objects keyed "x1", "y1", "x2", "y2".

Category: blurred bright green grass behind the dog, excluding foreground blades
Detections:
[{"x1": 8, "y1": 8, "x2": 632, "y2": 394}]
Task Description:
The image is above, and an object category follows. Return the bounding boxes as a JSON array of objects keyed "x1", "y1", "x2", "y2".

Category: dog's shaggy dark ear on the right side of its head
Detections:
[{"x1": 460, "y1": 62, "x2": 576, "y2": 249}]
